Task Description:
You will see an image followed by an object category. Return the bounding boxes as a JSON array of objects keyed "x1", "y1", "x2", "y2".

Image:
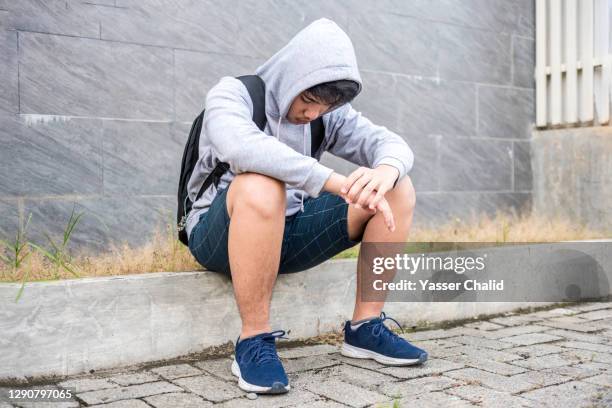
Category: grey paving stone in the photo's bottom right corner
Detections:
[{"x1": 521, "y1": 381, "x2": 609, "y2": 408}]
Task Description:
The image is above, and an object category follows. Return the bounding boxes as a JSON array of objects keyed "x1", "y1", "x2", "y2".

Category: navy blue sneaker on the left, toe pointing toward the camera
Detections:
[{"x1": 232, "y1": 330, "x2": 290, "y2": 394}]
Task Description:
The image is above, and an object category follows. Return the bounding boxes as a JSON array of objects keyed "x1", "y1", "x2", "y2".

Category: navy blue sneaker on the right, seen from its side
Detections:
[{"x1": 340, "y1": 312, "x2": 427, "y2": 366}]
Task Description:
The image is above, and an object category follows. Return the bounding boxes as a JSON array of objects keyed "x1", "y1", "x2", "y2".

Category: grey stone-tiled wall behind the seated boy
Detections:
[{"x1": 0, "y1": 0, "x2": 534, "y2": 255}]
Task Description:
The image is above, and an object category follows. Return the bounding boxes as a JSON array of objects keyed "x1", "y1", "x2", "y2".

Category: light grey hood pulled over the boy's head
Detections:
[{"x1": 255, "y1": 18, "x2": 361, "y2": 119}]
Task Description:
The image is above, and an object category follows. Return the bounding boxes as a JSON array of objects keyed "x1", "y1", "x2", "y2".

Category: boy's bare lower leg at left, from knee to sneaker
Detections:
[{"x1": 227, "y1": 173, "x2": 286, "y2": 339}]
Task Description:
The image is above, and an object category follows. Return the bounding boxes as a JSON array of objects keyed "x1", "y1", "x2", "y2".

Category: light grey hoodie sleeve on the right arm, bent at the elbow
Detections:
[{"x1": 325, "y1": 103, "x2": 414, "y2": 181}]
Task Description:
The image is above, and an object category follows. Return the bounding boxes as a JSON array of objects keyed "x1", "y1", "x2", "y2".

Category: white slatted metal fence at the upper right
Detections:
[{"x1": 534, "y1": 0, "x2": 612, "y2": 127}]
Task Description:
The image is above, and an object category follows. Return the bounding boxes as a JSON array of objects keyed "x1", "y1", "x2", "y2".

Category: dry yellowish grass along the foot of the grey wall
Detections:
[{"x1": 0, "y1": 213, "x2": 612, "y2": 282}]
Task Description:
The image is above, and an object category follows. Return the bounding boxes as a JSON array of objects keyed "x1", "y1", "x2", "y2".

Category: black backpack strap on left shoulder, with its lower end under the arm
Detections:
[{"x1": 193, "y1": 75, "x2": 267, "y2": 203}]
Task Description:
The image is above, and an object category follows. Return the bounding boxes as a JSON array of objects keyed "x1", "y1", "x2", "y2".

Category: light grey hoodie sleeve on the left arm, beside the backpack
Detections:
[{"x1": 202, "y1": 77, "x2": 333, "y2": 197}]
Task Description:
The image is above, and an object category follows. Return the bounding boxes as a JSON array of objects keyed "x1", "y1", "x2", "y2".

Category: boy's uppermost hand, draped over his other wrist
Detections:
[{"x1": 340, "y1": 164, "x2": 399, "y2": 210}]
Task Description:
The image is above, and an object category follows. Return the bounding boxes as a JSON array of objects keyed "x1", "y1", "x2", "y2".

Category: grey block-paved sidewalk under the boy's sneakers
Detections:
[{"x1": 0, "y1": 302, "x2": 612, "y2": 408}]
